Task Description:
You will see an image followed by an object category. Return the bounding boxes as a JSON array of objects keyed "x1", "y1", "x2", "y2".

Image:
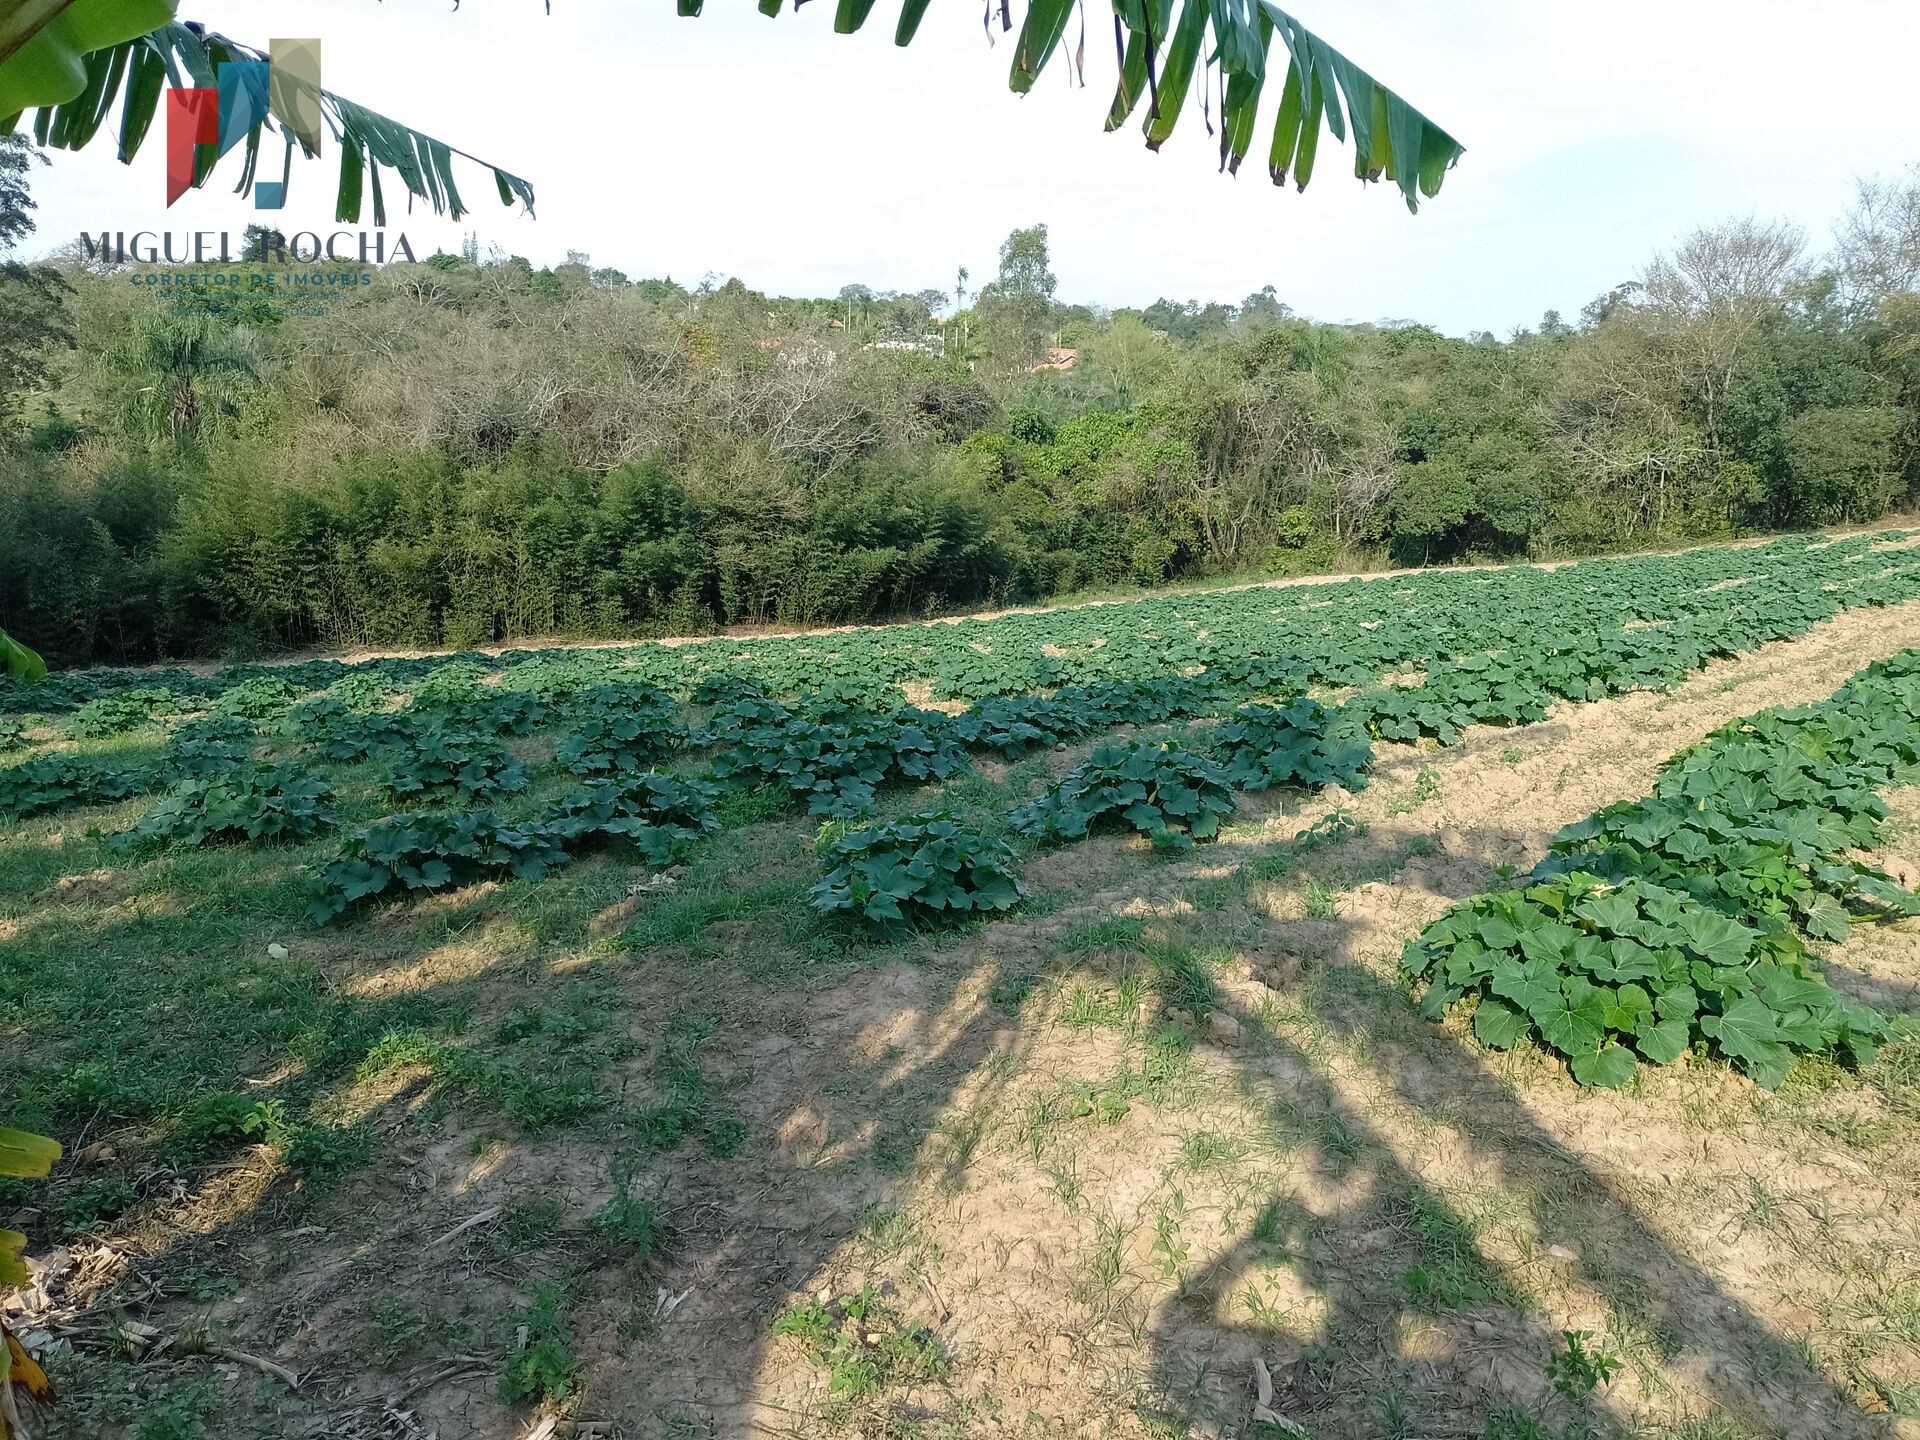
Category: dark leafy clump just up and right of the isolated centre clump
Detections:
[{"x1": 1006, "y1": 741, "x2": 1233, "y2": 851}]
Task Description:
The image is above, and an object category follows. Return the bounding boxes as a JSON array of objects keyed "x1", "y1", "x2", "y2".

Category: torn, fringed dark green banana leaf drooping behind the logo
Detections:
[{"x1": 0, "y1": 20, "x2": 534, "y2": 225}]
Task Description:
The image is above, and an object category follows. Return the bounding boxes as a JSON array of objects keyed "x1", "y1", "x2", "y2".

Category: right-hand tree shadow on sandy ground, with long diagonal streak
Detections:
[{"x1": 1154, "y1": 829, "x2": 1876, "y2": 1436}]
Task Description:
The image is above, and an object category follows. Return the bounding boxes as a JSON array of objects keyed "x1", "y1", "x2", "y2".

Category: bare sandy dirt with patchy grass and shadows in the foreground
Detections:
[{"x1": 11, "y1": 603, "x2": 1920, "y2": 1440}]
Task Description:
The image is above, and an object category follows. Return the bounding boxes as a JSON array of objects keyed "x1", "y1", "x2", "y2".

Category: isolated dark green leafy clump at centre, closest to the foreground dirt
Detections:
[{"x1": 806, "y1": 810, "x2": 1023, "y2": 931}]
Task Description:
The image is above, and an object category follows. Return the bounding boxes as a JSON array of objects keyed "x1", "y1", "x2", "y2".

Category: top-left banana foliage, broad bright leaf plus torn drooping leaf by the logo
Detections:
[{"x1": 0, "y1": 0, "x2": 534, "y2": 225}]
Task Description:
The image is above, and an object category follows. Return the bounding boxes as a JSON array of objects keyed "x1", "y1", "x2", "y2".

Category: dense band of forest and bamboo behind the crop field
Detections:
[{"x1": 0, "y1": 142, "x2": 1920, "y2": 664}]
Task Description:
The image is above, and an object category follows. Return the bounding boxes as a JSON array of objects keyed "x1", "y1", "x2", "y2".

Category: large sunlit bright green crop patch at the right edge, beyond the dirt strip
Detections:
[{"x1": 1405, "y1": 653, "x2": 1920, "y2": 1089}]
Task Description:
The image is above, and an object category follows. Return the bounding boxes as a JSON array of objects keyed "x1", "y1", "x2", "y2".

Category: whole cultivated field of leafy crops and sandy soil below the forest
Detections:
[{"x1": 0, "y1": 532, "x2": 1920, "y2": 1440}]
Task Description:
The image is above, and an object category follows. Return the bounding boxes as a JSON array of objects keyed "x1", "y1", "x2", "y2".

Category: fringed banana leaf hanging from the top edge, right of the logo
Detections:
[{"x1": 714, "y1": 0, "x2": 1463, "y2": 211}]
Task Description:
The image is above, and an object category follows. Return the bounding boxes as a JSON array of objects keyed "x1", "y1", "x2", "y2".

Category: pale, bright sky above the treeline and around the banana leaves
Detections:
[{"x1": 15, "y1": 0, "x2": 1920, "y2": 334}]
